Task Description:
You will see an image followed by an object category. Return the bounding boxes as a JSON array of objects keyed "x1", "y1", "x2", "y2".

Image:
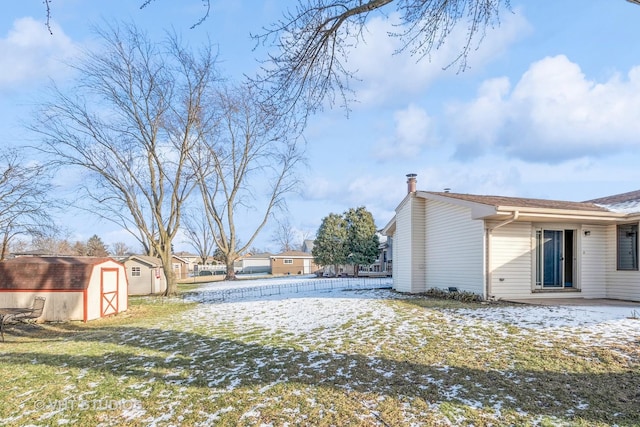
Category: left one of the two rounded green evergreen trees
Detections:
[{"x1": 311, "y1": 213, "x2": 348, "y2": 272}]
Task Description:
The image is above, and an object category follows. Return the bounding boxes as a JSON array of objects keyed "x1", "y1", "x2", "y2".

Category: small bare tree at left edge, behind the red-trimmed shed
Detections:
[{"x1": 0, "y1": 150, "x2": 53, "y2": 261}]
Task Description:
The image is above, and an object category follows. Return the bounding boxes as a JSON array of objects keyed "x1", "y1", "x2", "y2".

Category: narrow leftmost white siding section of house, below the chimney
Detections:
[{"x1": 393, "y1": 195, "x2": 426, "y2": 293}]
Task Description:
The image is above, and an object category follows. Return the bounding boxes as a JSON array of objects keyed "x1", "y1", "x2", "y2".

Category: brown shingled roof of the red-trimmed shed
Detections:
[{"x1": 0, "y1": 257, "x2": 115, "y2": 291}]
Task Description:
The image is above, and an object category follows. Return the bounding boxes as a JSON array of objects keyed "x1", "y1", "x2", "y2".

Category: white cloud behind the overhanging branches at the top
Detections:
[{"x1": 348, "y1": 7, "x2": 530, "y2": 105}]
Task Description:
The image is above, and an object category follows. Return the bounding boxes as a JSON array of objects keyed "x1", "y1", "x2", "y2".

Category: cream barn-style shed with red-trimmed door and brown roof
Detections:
[{"x1": 0, "y1": 257, "x2": 128, "y2": 322}]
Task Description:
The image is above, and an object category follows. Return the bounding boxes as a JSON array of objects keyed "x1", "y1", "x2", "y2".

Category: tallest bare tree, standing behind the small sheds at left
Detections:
[{"x1": 32, "y1": 25, "x2": 217, "y2": 294}]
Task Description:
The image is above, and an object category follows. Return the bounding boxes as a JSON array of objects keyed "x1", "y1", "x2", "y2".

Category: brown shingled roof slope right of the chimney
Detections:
[{"x1": 426, "y1": 191, "x2": 608, "y2": 212}]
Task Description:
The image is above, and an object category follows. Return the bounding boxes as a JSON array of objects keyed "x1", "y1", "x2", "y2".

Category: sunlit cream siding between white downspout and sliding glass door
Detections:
[{"x1": 489, "y1": 222, "x2": 533, "y2": 299}]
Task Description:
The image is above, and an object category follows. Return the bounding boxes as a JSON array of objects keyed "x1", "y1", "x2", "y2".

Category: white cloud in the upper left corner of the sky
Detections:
[{"x1": 0, "y1": 17, "x2": 77, "y2": 89}]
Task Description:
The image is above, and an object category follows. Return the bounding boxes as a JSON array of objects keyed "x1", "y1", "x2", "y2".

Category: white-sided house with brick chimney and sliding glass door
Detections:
[{"x1": 383, "y1": 174, "x2": 640, "y2": 301}]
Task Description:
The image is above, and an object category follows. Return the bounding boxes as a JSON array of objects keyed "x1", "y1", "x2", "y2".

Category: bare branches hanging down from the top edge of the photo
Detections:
[{"x1": 254, "y1": 0, "x2": 510, "y2": 114}]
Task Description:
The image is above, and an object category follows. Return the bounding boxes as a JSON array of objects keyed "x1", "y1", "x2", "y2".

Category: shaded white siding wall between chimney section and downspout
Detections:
[{"x1": 426, "y1": 200, "x2": 484, "y2": 295}]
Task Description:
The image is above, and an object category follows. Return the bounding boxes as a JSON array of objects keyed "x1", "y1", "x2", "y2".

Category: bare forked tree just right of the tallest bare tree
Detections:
[{"x1": 192, "y1": 85, "x2": 302, "y2": 279}]
